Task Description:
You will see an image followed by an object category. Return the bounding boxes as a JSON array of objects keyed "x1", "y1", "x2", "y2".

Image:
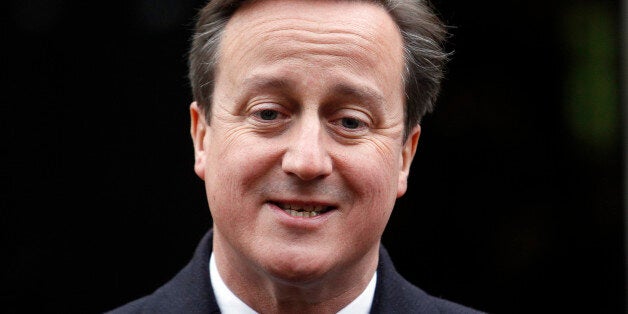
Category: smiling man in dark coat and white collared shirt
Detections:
[{"x1": 108, "y1": 0, "x2": 484, "y2": 313}]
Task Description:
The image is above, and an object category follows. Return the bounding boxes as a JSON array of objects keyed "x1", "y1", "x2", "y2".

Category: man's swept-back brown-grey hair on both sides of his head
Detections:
[{"x1": 188, "y1": 0, "x2": 449, "y2": 140}]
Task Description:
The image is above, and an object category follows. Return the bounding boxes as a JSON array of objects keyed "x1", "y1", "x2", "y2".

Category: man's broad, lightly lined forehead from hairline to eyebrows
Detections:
[{"x1": 217, "y1": 0, "x2": 403, "y2": 109}]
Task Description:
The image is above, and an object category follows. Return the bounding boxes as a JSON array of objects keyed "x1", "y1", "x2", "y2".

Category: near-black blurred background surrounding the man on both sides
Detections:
[{"x1": 0, "y1": 0, "x2": 626, "y2": 313}]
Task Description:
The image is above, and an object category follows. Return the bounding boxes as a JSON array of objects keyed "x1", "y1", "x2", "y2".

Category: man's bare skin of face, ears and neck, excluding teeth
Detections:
[{"x1": 190, "y1": 0, "x2": 420, "y2": 313}]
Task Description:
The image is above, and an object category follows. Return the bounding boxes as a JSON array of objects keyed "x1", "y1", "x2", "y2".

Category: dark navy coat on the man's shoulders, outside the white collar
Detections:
[{"x1": 108, "y1": 230, "x2": 480, "y2": 314}]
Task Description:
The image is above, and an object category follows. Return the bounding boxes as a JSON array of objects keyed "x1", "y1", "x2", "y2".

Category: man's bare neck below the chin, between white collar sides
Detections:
[{"x1": 213, "y1": 229, "x2": 379, "y2": 313}]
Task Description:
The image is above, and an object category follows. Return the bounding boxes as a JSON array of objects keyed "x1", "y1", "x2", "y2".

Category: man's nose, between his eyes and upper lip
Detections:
[{"x1": 281, "y1": 118, "x2": 332, "y2": 181}]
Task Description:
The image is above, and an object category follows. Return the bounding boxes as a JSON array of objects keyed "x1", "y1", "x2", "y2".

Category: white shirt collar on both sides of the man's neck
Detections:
[{"x1": 209, "y1": 252, "x2": 377, "y2": 314}]
